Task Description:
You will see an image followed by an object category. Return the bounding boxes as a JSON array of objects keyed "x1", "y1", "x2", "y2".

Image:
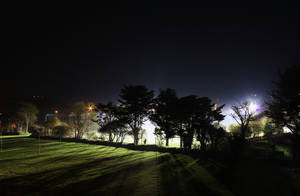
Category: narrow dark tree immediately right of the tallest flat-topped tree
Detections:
[{"x1": 150, "y1": 88, "x2": 178, "y2": 146}]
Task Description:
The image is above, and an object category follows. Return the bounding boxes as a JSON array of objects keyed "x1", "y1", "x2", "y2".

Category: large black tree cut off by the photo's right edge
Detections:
[{"x1": 266, "y1": 65, "x2": 300, "y2": 159}]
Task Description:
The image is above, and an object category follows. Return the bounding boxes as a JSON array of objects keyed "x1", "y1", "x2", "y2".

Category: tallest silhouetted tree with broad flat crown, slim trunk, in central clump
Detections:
[{"x1": 119, "y1": 85, "x2": 154, "y2": 145}]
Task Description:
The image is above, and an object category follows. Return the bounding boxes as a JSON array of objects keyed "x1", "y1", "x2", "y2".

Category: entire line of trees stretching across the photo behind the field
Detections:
[{"x1": 1, "y1": 65, "x2": 300, "y2": 160}]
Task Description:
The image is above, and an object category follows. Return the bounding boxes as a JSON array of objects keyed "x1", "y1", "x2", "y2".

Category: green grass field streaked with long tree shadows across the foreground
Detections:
[{"x1": 0, "y1": 137, "x2": 299, "y2": 196}]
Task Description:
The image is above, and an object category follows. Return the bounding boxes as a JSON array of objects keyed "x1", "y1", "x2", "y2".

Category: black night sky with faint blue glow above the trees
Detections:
[{"x1": 0, "y1": 3, "x2": 300, "y2": 106}]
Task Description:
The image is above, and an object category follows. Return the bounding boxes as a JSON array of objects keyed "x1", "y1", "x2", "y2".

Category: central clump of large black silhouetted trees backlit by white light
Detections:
[{"x1": 97, "y1": 86, "x2": 225, "y2": 150}]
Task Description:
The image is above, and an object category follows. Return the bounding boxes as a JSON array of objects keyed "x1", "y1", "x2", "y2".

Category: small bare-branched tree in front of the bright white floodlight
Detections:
[{"x1": 230, "y1": 101, "x2": 255, "y2": 139}]
